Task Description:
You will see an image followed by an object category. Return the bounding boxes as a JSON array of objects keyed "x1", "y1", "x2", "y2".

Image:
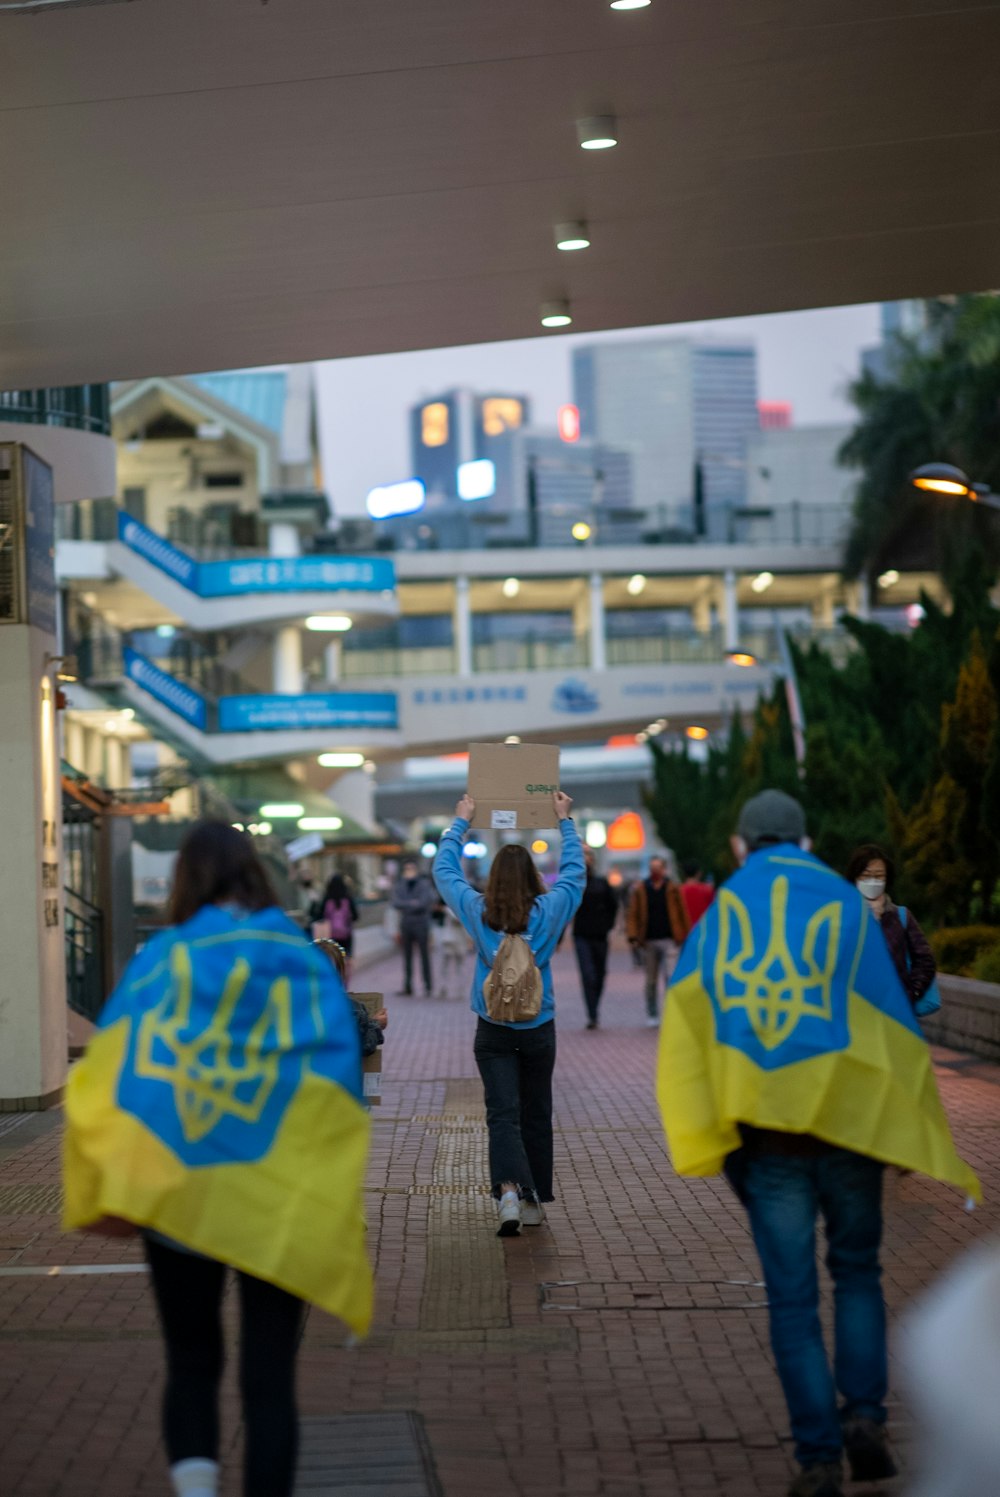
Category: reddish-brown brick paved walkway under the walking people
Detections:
[{"x1": 0, "y1": 952, "x2": 1000, "y2": 1497}]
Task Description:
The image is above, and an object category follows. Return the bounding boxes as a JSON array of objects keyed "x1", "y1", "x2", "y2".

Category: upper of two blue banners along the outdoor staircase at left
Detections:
[{"x1": 118, "y1": 512, "x2": 395, "y2": 597}]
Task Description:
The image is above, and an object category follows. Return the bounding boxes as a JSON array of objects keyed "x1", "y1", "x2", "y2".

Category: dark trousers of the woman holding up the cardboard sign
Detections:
[{"x1": 476, "y1": 1019, "x2": 555, "y2": 1201}]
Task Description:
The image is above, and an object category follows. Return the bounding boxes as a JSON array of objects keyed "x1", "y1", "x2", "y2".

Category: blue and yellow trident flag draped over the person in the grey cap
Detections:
[{"x1": 657, "y1": 844, "x2": 981, "y2": 1199}]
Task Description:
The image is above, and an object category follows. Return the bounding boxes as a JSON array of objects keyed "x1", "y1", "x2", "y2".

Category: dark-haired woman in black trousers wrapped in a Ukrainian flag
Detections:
[{"x1": 64, "y1": 822, "x2": 371, "y2": 1497}]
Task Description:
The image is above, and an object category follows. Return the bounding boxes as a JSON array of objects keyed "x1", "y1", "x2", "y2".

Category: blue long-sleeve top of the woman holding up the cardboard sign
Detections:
[{"x1": 434, "y1": 816, "x2": 587, "y2": 1028}]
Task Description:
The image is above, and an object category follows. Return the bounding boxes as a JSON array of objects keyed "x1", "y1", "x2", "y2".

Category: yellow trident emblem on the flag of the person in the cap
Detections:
[{"x1": 716, "y1": 877, "x2": 843, "y2": 1049}]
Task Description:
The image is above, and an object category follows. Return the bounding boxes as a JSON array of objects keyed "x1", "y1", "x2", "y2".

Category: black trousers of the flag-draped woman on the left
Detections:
[{"x1": 145, "y1": 1238, "x2": 302, "y2": 1497}]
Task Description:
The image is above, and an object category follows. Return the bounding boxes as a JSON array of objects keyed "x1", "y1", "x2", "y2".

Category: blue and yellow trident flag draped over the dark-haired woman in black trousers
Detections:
[{"x1": 63, "y1": 906, "x2": 371, "y2": 1334}]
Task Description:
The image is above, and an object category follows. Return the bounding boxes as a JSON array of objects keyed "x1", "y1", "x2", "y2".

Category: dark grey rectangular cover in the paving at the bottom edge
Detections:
[{"x1": 295, "y1": 1413, "x2": 442, "y2": 1497}]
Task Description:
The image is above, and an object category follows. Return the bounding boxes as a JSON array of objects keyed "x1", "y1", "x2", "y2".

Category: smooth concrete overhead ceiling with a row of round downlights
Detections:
[{"x1": 0, "y1": 0, "x2": 1000, "y2": 388}]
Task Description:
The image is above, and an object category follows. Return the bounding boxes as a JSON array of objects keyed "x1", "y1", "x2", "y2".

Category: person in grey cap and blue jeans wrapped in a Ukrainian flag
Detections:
[{"x1": 657, "y1": 790, "x2": 981, "y2": 1497}]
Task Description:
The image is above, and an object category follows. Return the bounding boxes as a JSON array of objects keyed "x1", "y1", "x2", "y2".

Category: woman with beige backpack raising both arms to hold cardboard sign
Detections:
[{"x1": 434, "y1": 790, "x2": 587, "y2": 1237}]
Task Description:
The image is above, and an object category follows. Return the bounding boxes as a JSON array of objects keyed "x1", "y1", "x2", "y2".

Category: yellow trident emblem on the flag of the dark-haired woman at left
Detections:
[{"x1": 135, "y1": 945, "x2": 292, "y2": 1144}]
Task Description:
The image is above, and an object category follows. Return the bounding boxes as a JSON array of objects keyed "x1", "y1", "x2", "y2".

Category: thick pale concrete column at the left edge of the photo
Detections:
[{"x1": 0, "y1": 624, "x2": 66, "y2": 1111}]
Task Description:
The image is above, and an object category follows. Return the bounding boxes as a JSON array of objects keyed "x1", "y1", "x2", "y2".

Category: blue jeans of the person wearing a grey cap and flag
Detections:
[{"x1": 743, "y1": 1148, "x2": 888, "y2": 1466}]
